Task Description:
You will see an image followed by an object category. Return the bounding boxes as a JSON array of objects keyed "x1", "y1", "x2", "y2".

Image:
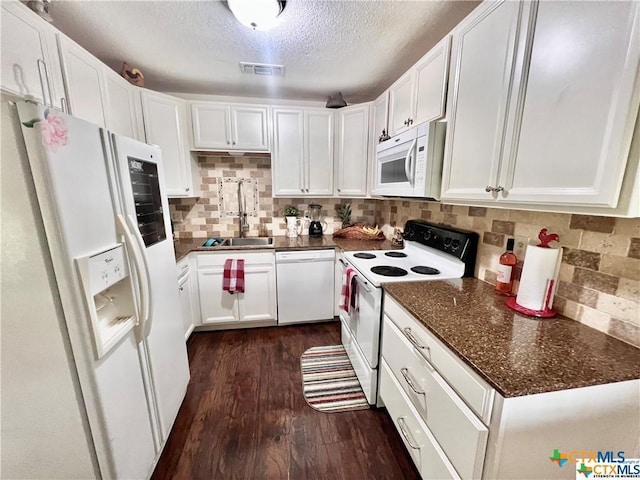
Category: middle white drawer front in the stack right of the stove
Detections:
[{"x1": 382, "y1": 315, "x2": 488, "y2": 478}]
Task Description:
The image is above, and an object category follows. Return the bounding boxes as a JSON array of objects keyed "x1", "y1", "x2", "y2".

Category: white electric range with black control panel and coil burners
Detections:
[{"x1": 339, "y1": 220, "x2": 478, "y2": 405}]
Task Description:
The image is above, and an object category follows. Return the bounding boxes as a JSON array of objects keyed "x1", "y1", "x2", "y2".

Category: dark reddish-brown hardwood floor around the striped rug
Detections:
[{"x1": 152, "y1": 322, "x2": 419, "y2": 480}]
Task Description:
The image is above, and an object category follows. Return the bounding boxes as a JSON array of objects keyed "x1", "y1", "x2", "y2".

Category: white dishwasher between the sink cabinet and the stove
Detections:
[{"x1": 276, "y1": 249, "x2": 335, "y2": 325}]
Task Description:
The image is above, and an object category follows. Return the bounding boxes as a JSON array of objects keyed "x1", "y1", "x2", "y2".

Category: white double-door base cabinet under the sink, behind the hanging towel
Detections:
[{"x1": 197, "y1": 251, "x2": 277, "y2": 328}]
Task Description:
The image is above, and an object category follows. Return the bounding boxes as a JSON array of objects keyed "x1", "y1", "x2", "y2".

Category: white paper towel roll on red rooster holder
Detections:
[{"x1": 516, "y1": 245, "x2": 562, "y2": 310}]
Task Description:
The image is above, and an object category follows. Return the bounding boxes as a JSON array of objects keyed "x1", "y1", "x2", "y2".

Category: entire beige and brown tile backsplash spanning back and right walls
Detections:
[{"x1": 169, "y1": 154, "x2": 640, "y2": 348}]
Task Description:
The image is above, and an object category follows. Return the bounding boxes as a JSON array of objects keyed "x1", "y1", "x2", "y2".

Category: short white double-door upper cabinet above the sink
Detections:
[{"x1": 191, "y1": 102, "x2": 269, "y2": 152}]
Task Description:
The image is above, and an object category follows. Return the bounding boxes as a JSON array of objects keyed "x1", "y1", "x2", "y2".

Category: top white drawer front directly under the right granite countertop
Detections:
[{"x1": 384, "y1": 296, "x2": 495, "y2": 425}]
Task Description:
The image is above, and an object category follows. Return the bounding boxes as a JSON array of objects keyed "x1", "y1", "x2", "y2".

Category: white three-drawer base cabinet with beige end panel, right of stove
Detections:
[{"x1": 380, "y1": 295, "x2": 640, "y2": 480}]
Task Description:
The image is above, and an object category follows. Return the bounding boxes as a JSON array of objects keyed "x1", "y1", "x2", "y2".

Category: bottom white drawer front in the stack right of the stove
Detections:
[{"x1": 380, "y1": 360, "x2": 460, "y2": 480}]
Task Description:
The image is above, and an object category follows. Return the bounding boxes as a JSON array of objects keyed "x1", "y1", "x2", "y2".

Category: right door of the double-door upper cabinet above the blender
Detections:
[{"x1": 304, "y1": 110, "x2": 333, "y2": 196}]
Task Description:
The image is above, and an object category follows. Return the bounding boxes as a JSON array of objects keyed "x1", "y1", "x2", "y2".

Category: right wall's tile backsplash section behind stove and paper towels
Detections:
[{"x1": 379, "y1": 200, "x2": 640, "y2": 347}]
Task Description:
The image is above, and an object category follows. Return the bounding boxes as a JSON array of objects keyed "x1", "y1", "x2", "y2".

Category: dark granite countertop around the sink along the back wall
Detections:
[{"x1": 173, "y1": 235, "x2": 398, "y2": 261}]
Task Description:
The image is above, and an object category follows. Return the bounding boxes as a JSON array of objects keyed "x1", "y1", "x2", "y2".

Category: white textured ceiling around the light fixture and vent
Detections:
[{"x1": 50, "y1": 0, "x2": 479, "y2": 104}]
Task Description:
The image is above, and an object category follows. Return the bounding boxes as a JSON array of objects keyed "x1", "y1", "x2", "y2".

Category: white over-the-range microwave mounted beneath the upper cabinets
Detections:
[{"x1": 373, "y1": 122, "x2": 446, "y2": 200}]
